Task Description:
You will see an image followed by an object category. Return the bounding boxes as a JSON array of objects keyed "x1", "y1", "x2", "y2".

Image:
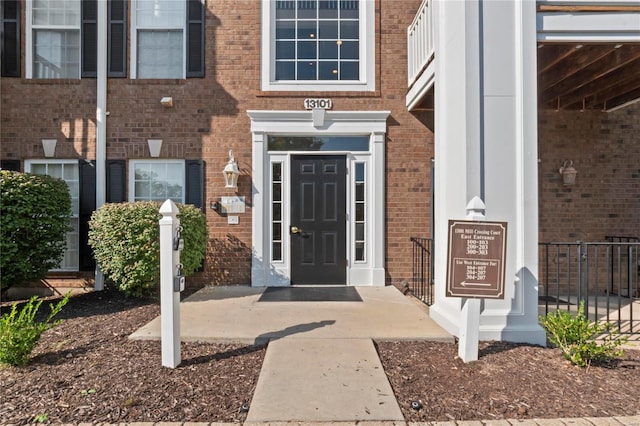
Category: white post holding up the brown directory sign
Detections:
[{"x1": 458, "y1": 197, "x2": 485, "y2": 362}]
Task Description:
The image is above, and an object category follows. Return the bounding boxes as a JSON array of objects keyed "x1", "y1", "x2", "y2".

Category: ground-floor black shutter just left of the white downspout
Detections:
[{"x1": 78, "y1": 160, "x2": 96, "y2": 271}]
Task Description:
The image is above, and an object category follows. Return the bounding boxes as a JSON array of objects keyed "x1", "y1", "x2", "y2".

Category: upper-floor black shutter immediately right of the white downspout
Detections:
[{"x1": 107, "y1": 0, "x2": 127, "y2": 77}]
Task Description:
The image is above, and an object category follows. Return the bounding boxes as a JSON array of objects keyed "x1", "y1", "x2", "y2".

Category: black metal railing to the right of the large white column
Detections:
[{"x1": 539, "y1": 237, "x2": 640, "y2": 333}]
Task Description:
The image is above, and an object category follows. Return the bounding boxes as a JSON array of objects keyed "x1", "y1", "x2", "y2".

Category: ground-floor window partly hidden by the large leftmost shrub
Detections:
[{"x1": 25, "y1": 160, "x2": 80, "y2": 271}]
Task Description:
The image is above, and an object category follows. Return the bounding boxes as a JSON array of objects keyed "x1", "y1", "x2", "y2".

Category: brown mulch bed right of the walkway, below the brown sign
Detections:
[{"x1": 378, "y1": 342, "x2": 640, "y2": 422}]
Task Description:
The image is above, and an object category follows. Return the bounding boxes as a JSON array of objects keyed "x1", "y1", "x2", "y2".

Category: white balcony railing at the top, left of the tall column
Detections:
[{"x1": 407, "y1": 0, "x2": 434, "y2": 87}]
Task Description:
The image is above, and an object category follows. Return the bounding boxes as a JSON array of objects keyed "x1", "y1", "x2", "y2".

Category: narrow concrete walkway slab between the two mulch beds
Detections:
[{"x1": 246, "y1": 338, "x2": 404, "y2": 422}]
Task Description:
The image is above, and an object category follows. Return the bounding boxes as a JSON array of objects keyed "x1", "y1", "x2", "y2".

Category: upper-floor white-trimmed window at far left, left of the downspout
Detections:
[{"x1": 27, "y1": 0, "x2": 81, "y2": 78}]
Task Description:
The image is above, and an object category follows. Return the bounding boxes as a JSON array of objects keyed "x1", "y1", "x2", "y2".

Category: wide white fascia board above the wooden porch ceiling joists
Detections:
[{"x1": 536, "y1": 12, "x2": 640, "y2": 42}]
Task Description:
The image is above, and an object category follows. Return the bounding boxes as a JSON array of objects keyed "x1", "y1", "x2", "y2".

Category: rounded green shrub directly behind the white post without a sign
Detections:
[{"x1": 89, "y1": 201, "x2": 208, "y2": 296}]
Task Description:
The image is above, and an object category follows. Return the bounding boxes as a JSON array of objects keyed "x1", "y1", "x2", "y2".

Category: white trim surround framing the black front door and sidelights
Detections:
[{"x1": 247, "y1": 110, "x2": 389, "y2": 287}]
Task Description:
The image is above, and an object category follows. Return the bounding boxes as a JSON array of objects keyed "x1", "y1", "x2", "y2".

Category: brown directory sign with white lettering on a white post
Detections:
[{"x1": 446, "y1": 220, "x2": 507, "y2": 299}]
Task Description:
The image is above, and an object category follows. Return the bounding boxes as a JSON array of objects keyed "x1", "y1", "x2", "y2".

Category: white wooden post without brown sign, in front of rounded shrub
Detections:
[{"x1": 160, "y1": 200, "x2": 181, "y2": 368}]
